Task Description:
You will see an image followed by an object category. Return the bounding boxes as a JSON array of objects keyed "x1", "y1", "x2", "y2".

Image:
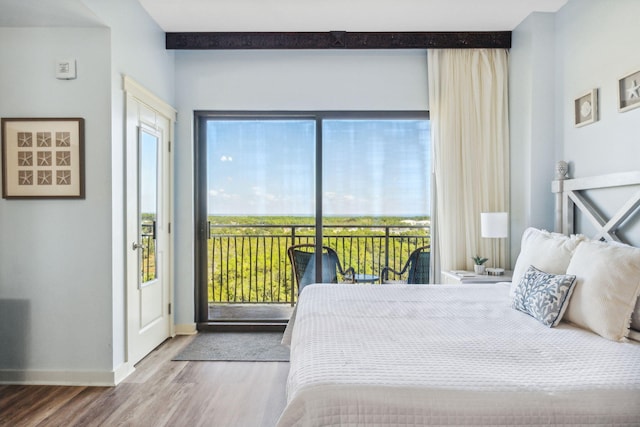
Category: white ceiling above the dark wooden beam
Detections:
[{"x1": 139, "y1": 0, "x2": 567, "y2": 32}]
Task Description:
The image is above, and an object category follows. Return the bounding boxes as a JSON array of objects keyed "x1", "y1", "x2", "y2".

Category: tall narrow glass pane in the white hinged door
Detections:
[{"x1": 138, "y1": 130, "x2": 158, "y2": 286}]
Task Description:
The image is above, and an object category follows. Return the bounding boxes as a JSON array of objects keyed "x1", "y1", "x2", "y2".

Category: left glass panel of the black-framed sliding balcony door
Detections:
[{"x1": 206, "y1": 118, "x2": 316, "y2": 321}]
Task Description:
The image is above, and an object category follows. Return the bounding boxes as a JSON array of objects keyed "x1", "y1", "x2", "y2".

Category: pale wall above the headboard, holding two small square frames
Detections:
[{"x1": 556, "y1": 0, "x2": 640, "y2": 177}]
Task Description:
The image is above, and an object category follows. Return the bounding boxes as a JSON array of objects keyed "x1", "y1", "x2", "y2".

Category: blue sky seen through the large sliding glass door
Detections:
[{"x1": 207, "y1": 119, "x2": 431, "y2": 216}]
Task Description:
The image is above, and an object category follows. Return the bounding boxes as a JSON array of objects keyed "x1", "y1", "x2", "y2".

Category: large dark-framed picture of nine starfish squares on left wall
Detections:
[{"x1": 2, "y1": 118, "x2": 84, "y2": 199}]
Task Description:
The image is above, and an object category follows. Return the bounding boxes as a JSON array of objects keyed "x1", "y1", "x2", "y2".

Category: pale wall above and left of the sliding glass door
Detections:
[{"x1": 175, "y1": 50, "x2": 428, "y2": 324}]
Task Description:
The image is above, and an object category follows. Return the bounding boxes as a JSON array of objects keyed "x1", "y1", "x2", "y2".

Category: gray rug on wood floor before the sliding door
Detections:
[{"x1": 173, "y1": 332, "x2": 289, "y2": 362}]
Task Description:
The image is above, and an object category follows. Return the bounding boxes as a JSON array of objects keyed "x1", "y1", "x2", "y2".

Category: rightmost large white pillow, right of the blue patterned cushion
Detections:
[{"x1": 564, "y1": 241, "x2": 640, "y2": 341}]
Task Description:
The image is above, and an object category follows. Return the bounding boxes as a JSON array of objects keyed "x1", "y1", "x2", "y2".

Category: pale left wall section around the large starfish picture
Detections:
[{"x1": 0, "y1": 28, "x2": 112, "y2": 378}]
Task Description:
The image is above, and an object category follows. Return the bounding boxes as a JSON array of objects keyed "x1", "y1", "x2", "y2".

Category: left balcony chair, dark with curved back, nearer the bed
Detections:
[{"x1": 287, "y1": 243, "x2": 355, "y2": 295}]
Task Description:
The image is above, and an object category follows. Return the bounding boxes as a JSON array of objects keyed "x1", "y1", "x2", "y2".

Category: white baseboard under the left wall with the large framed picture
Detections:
[{"x1": 0, "y1": 367, "x2": 127, "y2": 387}]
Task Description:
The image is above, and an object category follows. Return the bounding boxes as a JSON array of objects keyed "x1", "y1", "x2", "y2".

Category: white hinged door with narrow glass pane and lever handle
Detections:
[{"x1": 126, "y1": 81, "x2": 173, "y2": 365}]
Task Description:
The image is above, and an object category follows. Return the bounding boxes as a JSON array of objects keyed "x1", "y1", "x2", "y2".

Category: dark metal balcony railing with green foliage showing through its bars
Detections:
[{"x1": 208, "y1": 224, "x2": 431, "y2": 304}]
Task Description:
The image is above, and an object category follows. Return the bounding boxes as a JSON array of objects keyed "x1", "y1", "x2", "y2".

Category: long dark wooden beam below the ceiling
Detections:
[{"x1": 166, "y1": 31, "x2": 511, "y2": 50}]
